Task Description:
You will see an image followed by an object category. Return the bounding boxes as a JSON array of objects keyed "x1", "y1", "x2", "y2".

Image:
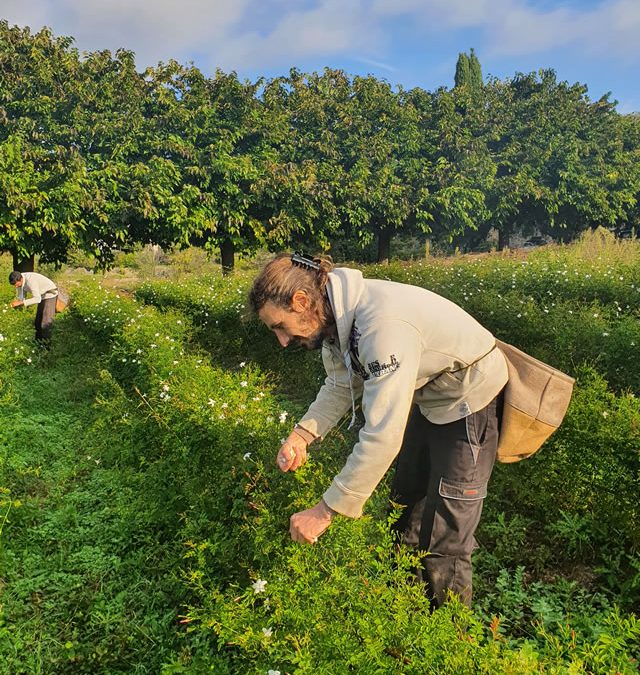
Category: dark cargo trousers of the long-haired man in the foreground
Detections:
[{"x1": 391, "y1": 395, "x2": 502, "y2": 607}]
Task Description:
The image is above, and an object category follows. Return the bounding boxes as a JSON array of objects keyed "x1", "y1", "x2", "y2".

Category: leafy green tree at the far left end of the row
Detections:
[{"x1": 0, "y1": 21, "x2": 89, "y2": 271}]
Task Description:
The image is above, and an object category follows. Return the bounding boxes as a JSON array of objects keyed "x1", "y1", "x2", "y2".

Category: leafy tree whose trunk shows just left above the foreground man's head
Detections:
[{"x1": 152, "y1": 62, "x2": 269, "y2": 273}]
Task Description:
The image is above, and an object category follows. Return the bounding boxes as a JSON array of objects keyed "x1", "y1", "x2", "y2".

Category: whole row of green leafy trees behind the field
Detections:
[{"x1": 0, "y1": 22, "x2": 640, "y2": 269}]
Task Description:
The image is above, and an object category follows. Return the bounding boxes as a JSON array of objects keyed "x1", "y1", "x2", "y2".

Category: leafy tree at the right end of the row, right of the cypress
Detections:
[{"x1": 487, "y1": 70, "x2": 634, "y2": 248}]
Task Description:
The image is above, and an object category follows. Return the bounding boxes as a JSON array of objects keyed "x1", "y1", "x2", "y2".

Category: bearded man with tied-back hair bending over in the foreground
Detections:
[{"x1": 249, "y1": 253, "x2": 508, "y2": 607}]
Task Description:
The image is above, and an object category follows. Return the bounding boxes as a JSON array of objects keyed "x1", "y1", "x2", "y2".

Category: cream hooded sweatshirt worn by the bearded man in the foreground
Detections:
[{"x1": 299, "y1": 268, "x2": 508, "y2": 518}]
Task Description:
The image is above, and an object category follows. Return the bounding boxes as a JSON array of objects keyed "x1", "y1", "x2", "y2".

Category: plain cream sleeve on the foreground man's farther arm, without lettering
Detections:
[{"x1": 298, "y1": 346, "x2": 362, "y2": 437}]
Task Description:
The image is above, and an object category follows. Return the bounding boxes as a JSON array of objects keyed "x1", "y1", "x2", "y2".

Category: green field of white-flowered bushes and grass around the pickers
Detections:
[{"x1": 0, "y1": 237, "x2": 640, "y2": 675}]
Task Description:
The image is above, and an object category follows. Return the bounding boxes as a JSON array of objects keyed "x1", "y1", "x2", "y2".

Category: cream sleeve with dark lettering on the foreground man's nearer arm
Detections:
[{"x1": 323, "y1": 321, "x2": 422, "y2": 518}]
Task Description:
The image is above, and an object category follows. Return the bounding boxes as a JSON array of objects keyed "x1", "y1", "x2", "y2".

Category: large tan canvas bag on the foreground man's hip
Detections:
[{"x1": 496, "y1": 340, "x2": 575, "y2": 463}]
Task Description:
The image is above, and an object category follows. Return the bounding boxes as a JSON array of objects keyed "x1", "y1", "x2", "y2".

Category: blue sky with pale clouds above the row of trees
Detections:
[{"x1": 5, "y1": 0, "x2": 640, "y2": 113}]
